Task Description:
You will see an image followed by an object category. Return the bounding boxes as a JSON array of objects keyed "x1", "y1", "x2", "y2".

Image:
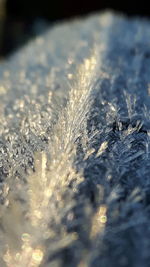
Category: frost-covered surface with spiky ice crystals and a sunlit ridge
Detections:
[{"x1": 0, "y1": 13, "x2": 150, "y2": 267}]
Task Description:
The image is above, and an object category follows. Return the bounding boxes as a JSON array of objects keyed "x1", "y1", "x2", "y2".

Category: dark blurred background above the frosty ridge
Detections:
[{"x1": 0, "y1": 0, "x2": 150, "y2": 58}]
